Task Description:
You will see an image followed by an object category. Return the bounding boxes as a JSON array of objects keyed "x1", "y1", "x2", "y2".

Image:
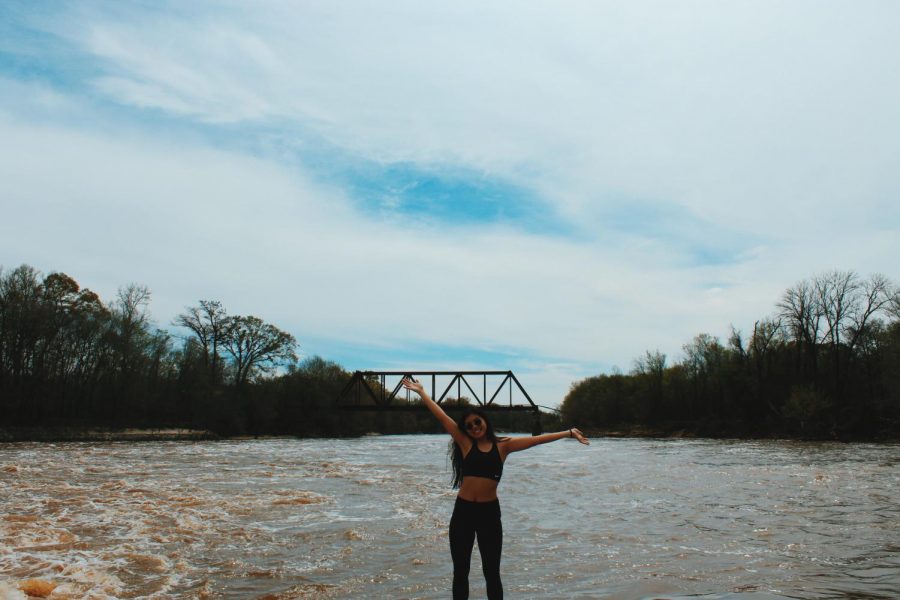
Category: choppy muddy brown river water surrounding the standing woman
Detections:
[{"x1": 0, "y1": 436, "x2": 900, "y2": 600}]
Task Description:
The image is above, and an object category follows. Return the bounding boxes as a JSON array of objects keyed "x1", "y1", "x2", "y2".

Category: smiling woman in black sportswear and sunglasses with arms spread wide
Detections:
[{"x1": 403, "y1": 378, "x2": 590, "y2": 600}]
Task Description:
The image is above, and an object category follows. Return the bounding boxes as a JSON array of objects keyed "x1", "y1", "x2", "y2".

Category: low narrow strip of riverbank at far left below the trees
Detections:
[{"x1": 0, "y1": 427, "x2": 221, "y2": 442}]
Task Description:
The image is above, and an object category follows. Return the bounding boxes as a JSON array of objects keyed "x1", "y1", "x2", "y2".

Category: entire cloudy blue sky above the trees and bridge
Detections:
[{"x1": 0, "y1": 0, "x2": 900, "y2": 406}]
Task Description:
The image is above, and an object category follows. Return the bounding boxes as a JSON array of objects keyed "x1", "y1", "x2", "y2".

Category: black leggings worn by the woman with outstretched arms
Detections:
[{"x1": 450, "y1": 497, "x2": 503, "y2": 600}]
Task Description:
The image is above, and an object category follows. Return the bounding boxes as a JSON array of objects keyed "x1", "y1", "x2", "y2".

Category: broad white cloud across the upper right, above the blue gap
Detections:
[{"x1": 51, "y1": 2, "x2": 900, "y2": 232}]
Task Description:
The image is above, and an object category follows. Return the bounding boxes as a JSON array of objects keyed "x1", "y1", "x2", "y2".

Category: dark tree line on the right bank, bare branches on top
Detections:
[{"x1": 561, "y1": 270, "x2": 900, "y2": 439}]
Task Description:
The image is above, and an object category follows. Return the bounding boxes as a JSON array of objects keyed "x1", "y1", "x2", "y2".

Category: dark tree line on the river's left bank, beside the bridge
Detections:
[{"x1": 0, "y1": 265, "x2": 548, "y2": 436}]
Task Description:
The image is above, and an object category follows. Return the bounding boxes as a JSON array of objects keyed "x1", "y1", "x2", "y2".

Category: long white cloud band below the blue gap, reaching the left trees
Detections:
[{"x1": 0, "y1": 112, "x2": 760, "y2": 402}]
